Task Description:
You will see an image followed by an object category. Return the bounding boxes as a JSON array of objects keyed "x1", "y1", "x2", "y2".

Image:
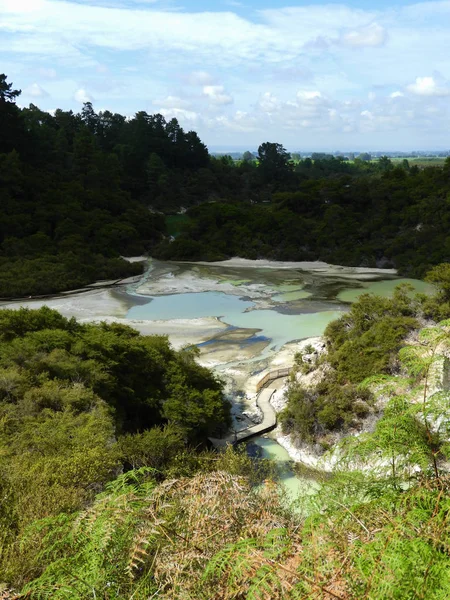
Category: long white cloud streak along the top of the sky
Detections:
[{"x1": 0, "y1": 0, "x2": 390, "y2": 68}]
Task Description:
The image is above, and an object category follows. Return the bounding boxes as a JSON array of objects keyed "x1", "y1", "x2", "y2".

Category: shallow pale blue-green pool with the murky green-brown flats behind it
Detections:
[{"x1": 122, "y1": 261, "x2": 432, "y2": 365}]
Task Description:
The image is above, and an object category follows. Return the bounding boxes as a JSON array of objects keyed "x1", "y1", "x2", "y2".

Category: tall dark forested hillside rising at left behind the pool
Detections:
[{"x1": 0, "y1": 75, "x2": 209, "y2": 297}]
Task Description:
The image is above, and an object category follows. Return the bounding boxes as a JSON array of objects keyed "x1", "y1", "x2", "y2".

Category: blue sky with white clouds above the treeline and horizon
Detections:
[{"x1": 0, "y1": 0, "x2": 450, "y2": 151}]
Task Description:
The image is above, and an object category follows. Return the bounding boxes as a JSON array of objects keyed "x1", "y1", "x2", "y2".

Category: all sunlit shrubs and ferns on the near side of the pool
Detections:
[{"x1": 0, "y1": 265, "x2": 450, "y2": 600}]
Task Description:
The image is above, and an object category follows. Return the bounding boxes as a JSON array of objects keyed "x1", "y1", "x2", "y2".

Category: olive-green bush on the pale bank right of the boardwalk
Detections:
[{"x1": 281, "y1": 285, "x2": 421, "y2": 442}]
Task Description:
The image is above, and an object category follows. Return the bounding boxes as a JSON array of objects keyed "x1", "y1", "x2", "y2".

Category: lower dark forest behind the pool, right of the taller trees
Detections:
[{"x1": 158, "y1": 158, "x2": 450, "y2": 276}]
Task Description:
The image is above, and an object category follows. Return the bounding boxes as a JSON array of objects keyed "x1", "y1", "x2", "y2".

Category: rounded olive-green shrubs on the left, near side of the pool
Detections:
[{"x1": 0, "y1": 307, "x2": 230, "y2": 582}]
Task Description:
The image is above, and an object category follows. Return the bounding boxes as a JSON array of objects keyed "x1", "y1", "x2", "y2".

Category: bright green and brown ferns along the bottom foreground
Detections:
[{"x1": 13, "y1": 471, "x2": 450, "y2": 600}]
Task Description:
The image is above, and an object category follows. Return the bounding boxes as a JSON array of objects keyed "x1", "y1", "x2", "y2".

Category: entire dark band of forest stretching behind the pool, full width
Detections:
[{"x1": 0, "y1": 75, "x2": 450, "y2": 298}]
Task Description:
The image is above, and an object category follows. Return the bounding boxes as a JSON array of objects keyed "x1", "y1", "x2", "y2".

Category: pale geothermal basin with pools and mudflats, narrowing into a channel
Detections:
[{"x1": 2, "y1": 259, "x2": 431, "y2": 497}]
